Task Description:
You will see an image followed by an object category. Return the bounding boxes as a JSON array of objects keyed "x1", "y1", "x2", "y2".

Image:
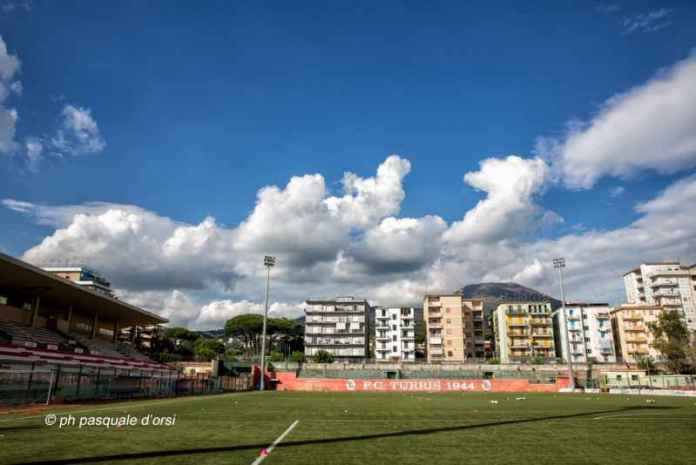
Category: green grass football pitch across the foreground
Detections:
[{"x1": 0, "y1": 392, "x2": 696, "y2": 465}]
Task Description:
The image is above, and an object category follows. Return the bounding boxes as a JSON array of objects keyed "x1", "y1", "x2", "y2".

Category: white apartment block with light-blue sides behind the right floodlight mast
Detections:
[{"x1": 553, "y1": 302, "x2": 616, "y2": 363}]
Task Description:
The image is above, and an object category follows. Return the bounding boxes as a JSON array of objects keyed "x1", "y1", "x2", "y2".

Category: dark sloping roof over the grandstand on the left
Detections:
[{"x1": 0, "y1": 253, "x2": 168, "y2": 326}]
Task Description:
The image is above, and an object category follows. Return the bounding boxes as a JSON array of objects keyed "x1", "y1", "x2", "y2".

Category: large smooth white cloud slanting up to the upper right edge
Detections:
[{"x1": 538, "y1": 52, "x2": 696, "y2": 188}]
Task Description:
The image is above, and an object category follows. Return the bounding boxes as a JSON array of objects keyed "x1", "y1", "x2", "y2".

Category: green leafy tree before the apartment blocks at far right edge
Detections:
[{"x1": 648, "y1": 310, "x2": 691, "y2": 373}]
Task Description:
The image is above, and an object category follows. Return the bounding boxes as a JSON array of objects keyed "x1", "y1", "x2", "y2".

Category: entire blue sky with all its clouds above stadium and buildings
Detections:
[{"x1": 0, "y1": 0, "x2": 696, "y2": 329}]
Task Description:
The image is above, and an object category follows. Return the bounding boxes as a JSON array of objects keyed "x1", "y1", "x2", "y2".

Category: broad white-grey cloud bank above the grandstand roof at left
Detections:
[{"x1": 10, "y1": 203, "x2": 235, "y2": 289}]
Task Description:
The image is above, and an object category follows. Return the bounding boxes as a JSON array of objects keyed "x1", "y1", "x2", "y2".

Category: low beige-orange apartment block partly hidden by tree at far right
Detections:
[{"x1": 610, "y1": 304, "x2": 670, "y2": 363}]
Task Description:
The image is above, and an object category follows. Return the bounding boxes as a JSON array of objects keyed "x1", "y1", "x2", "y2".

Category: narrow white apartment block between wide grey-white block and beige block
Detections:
[{"x1": 375, "y1": 307, "x2": 423, "y2": 362}]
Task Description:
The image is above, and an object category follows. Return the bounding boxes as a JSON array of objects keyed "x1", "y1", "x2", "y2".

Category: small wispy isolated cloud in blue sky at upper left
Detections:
[{"x1": 51, "y1": 105, "x2": 106, "y2": 155}]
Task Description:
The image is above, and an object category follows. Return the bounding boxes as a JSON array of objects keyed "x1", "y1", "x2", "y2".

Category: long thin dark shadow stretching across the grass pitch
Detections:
[{"x1": 12, "y1": 406, "x2": 676, "y2": 465}]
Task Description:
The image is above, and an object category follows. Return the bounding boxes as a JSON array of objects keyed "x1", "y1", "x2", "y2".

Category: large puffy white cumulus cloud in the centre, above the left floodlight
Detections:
[{"x1": 235, "y1": 155, "x2": 411, "y2": 267}]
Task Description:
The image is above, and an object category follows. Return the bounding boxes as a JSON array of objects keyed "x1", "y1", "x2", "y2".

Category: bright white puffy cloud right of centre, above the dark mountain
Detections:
[{"x1": 445, "y1": 155, "x2": 554, "y2": 244}]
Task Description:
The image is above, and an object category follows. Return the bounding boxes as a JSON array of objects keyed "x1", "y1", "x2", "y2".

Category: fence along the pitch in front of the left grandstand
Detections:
[{"x1": 0, "y1": 364, "x2": 252, "y2": 406}]
